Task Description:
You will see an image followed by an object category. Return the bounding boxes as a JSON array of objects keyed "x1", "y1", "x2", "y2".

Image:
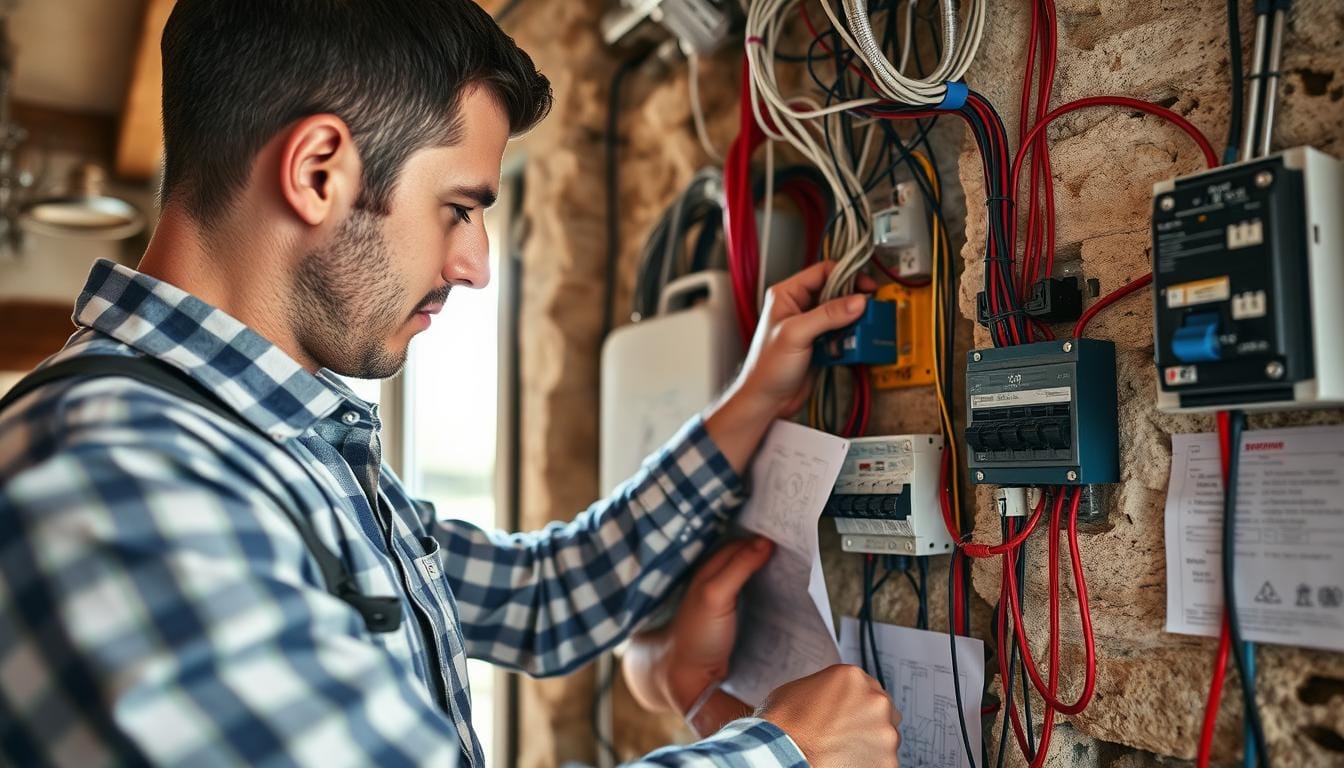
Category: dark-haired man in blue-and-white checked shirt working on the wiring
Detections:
[{"x1": 0, "y1": 0, "x2": 896, "y2": 765}]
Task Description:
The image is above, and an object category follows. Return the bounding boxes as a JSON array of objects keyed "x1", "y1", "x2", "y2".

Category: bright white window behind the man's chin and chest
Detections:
[{"x1": 392, "y1": 176, "x2": 515, "y2": 765}]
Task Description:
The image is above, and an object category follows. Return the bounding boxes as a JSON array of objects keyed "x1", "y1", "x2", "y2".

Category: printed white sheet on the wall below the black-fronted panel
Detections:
[{"x1": 1165, "y1": 426, "x2": 1344, "y2": 651}]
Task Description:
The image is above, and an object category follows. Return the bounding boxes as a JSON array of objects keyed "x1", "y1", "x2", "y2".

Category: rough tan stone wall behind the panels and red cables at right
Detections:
[{"x1": 961, "y1": 0, "x2": 1344, "y2": 767}]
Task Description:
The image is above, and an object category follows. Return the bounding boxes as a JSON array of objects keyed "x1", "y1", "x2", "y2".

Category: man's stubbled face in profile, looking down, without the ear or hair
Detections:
[{"x1": 292, "y1": 87, "x2": 509, "y2": 378}]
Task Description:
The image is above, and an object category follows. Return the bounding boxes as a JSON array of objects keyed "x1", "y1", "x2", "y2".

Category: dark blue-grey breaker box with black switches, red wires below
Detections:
[{"x1": 966, "y1": 339, "x2": 1120, "y2": 486}]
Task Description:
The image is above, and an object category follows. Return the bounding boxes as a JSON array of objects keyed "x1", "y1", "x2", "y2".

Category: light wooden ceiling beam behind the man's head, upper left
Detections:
[{"x1": 117, "y1": 0, "x2": 176, "y2": 180}]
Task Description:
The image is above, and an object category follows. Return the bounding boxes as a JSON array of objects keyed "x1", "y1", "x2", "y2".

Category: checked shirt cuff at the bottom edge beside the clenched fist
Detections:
[{"x1": 625, "y1": 717, "x2": 808, "y2": 768}]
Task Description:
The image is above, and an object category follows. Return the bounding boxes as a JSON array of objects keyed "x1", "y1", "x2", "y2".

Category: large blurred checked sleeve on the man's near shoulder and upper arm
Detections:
[{"x1": 0, "y1": 403, "x2": 460, "y2": 765}]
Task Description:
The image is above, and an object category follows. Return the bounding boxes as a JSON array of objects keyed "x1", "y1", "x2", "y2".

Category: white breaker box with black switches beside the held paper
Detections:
[{"x1": 823, "y1": 434, "x2": 953, "y2": 555}]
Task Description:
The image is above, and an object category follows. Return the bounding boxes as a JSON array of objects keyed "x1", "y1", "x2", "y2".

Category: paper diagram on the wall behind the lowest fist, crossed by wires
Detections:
[{"x1": 840, "y1": 616, "x2": 985, "y2": 768}]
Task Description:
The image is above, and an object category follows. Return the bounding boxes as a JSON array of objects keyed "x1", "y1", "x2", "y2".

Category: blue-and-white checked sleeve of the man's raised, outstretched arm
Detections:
[{"x1": 434, "y1": 417, "x2": 742, "y2": 675}]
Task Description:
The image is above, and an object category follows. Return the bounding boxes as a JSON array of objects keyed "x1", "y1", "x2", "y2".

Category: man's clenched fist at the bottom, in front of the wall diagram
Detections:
[{"x1": 757, "y1": 664, "x2": 900, "y2": 768}]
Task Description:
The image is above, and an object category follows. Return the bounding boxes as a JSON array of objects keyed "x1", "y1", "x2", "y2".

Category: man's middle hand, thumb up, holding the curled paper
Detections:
[{"x1": 621, "y1": 537, "x2": 774, "y2": 733}]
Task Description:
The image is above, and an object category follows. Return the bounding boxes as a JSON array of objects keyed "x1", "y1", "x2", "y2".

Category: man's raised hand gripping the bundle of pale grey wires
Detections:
[{"x1": 706, "y1": 261, "x2": 876, "y2": 473}]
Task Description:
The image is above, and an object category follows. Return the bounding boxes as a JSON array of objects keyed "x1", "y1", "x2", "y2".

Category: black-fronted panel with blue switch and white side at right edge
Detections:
[{"x1": 1153, "y1": 147, "x2": 1344, "y2": 412}]
